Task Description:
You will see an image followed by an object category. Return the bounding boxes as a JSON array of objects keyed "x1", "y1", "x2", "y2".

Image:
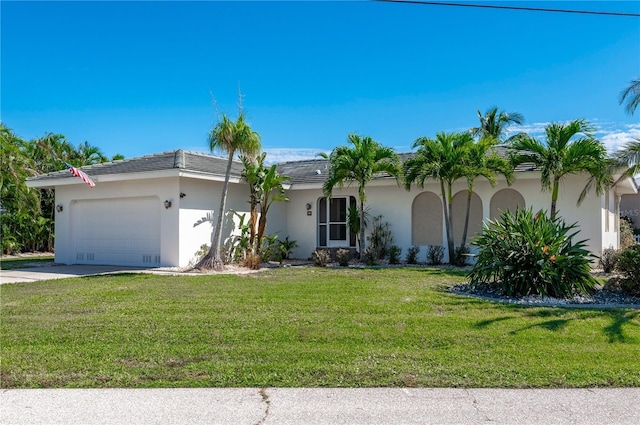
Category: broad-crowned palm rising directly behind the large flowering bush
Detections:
[{"x1": 509, "y1": 119, "x2": 611, "y2": 218}]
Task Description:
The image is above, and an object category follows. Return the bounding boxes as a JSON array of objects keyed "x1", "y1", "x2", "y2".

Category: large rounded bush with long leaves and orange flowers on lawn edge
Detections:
[{"x1": 468, "y1": 209, "x2": 597, "y2": 298}]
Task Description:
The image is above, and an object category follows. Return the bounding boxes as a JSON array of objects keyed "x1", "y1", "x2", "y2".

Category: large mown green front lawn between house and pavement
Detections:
[{"x1": 0, "y1": 268, "x2": 640, "y2": 388}]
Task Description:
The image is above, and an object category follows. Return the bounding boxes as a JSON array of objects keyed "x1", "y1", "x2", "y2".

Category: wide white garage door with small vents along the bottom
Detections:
[{"x1": 71, "y1": 197, "x2": 162, "y2": 266}]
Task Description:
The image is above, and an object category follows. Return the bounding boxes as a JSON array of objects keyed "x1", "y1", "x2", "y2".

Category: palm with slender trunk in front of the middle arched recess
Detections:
[{"x1": 460, "y1": 137, "x2": 513, "y2": 248}]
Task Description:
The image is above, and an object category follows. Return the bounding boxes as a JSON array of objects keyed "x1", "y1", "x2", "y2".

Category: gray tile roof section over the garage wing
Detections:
[{"x1": 27, "y1": 149, "x2": 243, "y2": 181}]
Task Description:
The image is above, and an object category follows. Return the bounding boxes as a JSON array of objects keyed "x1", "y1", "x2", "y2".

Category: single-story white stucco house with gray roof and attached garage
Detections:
[{"x1": 27, "y1": 149, "x2": 638, "y2": 267}]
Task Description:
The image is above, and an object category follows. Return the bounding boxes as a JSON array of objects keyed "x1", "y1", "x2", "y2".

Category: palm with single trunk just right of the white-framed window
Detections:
[{"x1": 319, "y1": 134, "x2": 401, "y2": 254}]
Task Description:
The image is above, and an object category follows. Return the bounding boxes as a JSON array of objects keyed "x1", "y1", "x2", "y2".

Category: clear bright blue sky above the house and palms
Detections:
[{"x1": 0, "y1": 1, "x2": 640, "y2": 161}]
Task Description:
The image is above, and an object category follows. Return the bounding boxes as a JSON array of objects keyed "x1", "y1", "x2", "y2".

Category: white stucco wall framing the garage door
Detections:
[{"x1": 55, "y1": 177, "x2": 178, "y2": 266}]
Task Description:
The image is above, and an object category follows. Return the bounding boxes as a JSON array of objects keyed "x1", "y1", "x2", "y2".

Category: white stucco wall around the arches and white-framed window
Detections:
[{"x1": 286, "y1": 172, "x2": 618, "y2": 260}]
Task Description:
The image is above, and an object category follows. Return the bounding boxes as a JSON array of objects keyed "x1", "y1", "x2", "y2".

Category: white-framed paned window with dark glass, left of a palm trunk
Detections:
[{"x1": 318, "y1": 196, "x2": 356, "y2": 247}]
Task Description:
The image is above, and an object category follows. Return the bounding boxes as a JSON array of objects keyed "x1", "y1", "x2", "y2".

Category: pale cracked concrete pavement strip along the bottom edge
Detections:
[{"x1": 0, "y1": 388, "x2": 640, "y2": 425}]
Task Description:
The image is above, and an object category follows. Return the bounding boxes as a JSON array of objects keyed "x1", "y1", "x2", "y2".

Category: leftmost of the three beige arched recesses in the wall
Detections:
[{"x1": 411, "y1": 192, "x2": 442, "y2": 246}]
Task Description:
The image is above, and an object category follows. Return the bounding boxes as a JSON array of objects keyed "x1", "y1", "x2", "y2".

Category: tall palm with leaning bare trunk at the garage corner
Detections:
[{"x1": 196, "y1": 111, "x2": 260, "y2": 271}]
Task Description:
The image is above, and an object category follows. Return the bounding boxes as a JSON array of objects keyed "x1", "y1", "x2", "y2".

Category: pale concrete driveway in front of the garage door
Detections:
[{"x1": 0, "y1": 264, "x2": 148, "y2": 284}]
